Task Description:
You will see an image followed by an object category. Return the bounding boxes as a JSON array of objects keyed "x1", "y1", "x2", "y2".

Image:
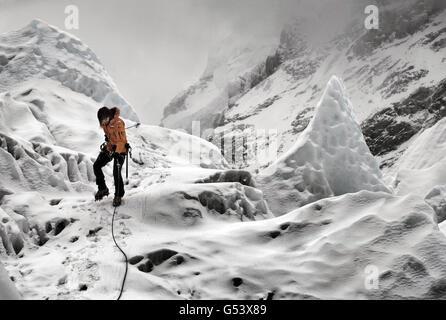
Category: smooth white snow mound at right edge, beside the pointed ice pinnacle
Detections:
[{"x1": 394, "y1": 119, "x2": 446, "y2": 195}]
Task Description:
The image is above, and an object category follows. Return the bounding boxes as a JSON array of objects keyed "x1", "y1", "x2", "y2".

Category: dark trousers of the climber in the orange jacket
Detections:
[{"x1": 93, "y1": 152, "x2": 125, "y2": 198}]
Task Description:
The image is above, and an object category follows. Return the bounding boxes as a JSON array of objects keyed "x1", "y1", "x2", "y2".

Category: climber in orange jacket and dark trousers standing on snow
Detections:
[{"x1": 93, "y1": 107, "x2": 130, "y2": 207}]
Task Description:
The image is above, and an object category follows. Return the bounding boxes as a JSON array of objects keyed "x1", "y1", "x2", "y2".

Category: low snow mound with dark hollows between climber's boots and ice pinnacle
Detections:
[{"x1": 123, "y1": 182, "x2": 273, "y2": 227}]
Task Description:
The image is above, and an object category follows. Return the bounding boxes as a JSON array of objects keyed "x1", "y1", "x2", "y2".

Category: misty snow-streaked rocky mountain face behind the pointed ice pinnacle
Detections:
[{"x1": 163, "y1": 0, "x2": 446, "y2": 171}]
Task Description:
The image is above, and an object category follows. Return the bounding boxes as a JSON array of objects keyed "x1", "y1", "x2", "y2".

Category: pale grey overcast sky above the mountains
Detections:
[{"x1": 0, "y1": 0, "x2": 368, "y2": 124}]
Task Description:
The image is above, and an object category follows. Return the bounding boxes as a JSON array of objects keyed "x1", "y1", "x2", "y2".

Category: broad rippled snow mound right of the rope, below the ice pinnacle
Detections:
[{"x1": 128, "y1": 191, "x2": 446, "y2": 299}]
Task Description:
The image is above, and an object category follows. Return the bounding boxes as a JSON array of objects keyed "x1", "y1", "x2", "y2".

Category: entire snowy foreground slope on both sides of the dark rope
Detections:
[{"x1": 8, "y1": 190, "x2": 446, "y2": 299}]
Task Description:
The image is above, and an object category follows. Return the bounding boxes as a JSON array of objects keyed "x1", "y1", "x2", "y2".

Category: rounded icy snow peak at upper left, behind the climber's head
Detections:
[{"x1": 0, "y1": 20, "x2": 138, "y2": 121}]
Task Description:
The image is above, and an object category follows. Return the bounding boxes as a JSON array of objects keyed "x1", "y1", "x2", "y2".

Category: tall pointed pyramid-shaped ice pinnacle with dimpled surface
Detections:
[{"x1": 258, "y1": 76, "x2": 390, "y2": 215}]
